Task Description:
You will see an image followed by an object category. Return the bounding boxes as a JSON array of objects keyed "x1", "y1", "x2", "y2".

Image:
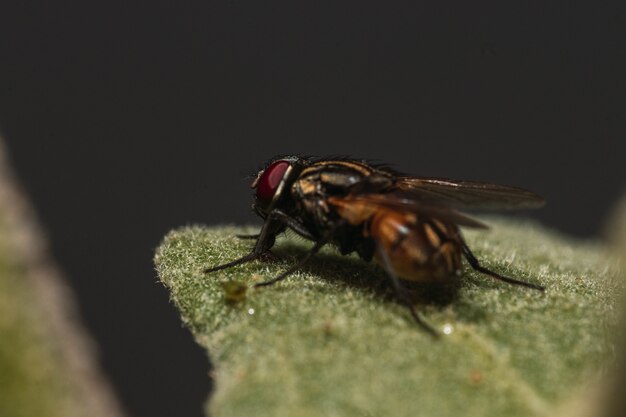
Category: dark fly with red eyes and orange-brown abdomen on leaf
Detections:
[{"x1": 205, "y1": 156, "x2": 544, "y2": 334}]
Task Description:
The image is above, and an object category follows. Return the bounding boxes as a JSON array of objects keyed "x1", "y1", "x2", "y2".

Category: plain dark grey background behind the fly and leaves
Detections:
[{"x1": 0, "y1": 0, "x2": 626, "y2": 417}]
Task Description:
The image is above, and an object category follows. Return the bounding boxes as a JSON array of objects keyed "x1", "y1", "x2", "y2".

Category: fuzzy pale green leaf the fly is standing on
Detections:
[{"x1": 155, "y1": 219, "x2": 621, "y2": 417}]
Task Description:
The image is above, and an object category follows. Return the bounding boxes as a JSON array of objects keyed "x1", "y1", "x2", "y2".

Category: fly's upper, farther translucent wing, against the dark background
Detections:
[{"x1": 394, "y1": 177, "x2": 545, "y2": 210}]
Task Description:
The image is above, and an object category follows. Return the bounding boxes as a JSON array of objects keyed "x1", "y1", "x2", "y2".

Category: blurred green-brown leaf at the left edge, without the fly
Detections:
[{"x1": 0, "y1": 138, "x2": 123, "y2": 417}]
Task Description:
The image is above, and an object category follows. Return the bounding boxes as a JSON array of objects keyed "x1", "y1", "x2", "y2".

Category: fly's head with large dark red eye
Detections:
[{"x1": 251, "y1": 156, "x2": 307, "y2": 218}]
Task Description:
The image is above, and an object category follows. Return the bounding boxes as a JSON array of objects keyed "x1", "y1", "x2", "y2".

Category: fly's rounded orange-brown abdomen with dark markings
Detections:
[{"x1": 369, "y1": 210, "x2": 461, "y2": 282}]
